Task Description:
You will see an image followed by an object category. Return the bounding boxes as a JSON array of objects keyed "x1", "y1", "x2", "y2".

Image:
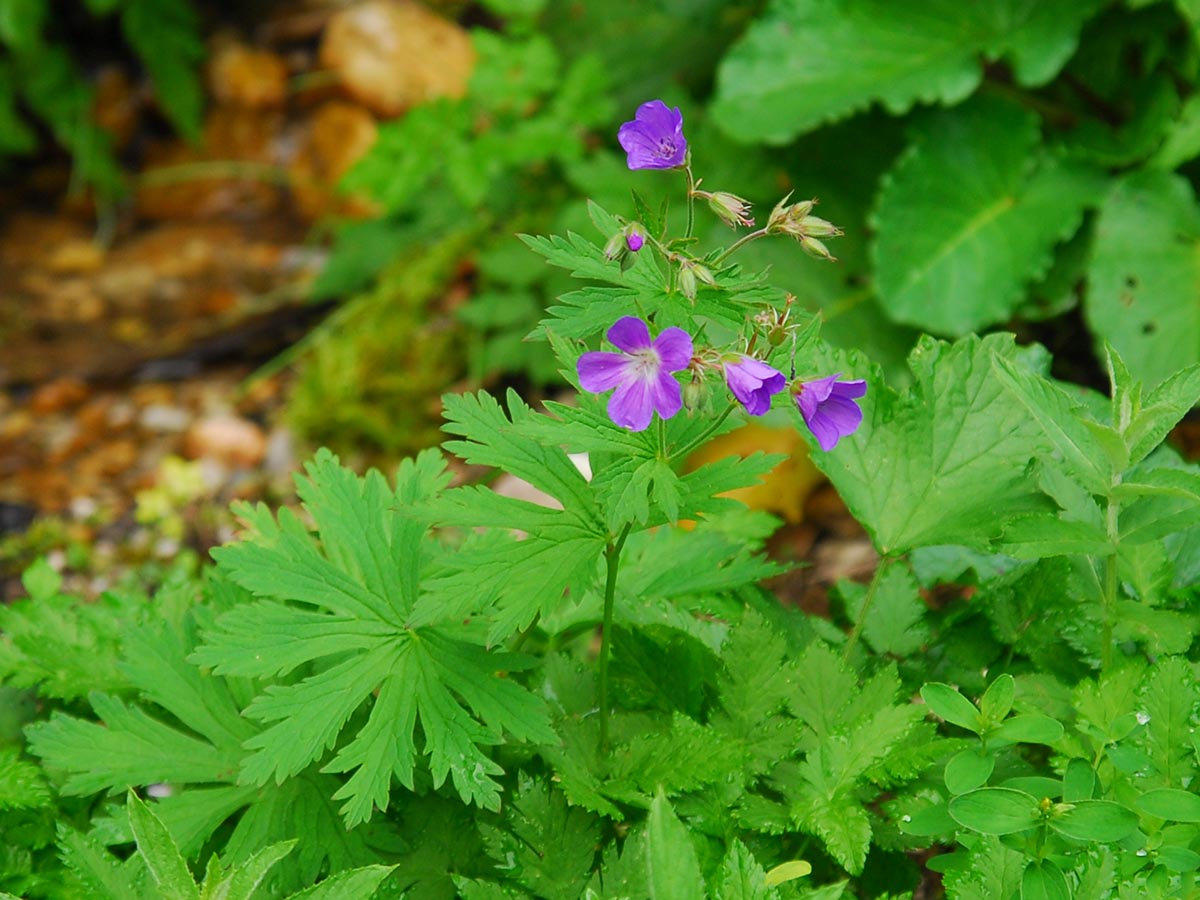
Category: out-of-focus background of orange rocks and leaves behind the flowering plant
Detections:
[{"x1": 0, "y1": 0, "x2": 1200, "y2": 607}]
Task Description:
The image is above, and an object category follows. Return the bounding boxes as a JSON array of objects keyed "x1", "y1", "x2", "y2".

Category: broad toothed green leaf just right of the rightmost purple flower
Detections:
[{"x1": 812, "y1": 335, "x2": 1048, "y2": 554}]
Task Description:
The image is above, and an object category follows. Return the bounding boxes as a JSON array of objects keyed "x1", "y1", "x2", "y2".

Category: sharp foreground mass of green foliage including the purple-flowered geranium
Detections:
[{"x1": 7, "y1": 101, "x2": 1200, "y2": 900}]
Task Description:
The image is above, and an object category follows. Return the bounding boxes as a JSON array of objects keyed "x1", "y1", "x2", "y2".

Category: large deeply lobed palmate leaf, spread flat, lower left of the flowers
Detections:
[{"x1": 200, "y1": 451, "x2": 552, "y2": 826}]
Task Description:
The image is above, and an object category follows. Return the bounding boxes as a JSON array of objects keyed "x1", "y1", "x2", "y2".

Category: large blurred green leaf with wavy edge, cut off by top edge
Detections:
[{"x1": 713, "y1": 0, "x2": 1099, "y2": 144}]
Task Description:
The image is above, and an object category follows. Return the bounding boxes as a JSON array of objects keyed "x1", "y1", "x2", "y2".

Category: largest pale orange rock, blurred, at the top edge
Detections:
[{"x1": 320, "y1": 0, "x2": 475, "y2": 116}]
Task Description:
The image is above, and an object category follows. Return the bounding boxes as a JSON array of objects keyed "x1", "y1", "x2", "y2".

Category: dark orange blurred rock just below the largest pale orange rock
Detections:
[{"x1": 290, "y1": 101, "x2": 378, "y2": 221}]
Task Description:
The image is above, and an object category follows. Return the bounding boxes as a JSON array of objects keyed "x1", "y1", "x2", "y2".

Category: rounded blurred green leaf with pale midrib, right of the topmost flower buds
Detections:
[{"x1": 872, "y1": 97, "x2": 1103, "y2": 337}]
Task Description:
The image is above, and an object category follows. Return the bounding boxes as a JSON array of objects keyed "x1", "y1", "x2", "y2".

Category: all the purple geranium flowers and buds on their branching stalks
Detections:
[{"x1": 577, "y1": 100, "x2": 866, "y2": 451}]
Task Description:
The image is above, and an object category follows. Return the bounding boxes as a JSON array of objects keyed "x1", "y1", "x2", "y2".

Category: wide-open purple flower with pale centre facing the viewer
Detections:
[{"x1": 577, "y1": 316, "x2": 691, "y2": 431}]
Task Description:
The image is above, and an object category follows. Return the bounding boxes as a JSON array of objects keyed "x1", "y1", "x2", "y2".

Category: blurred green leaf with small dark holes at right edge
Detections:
[{"x1": 1084, "y1": 172, "x2": 1200, "y2": 385}]
